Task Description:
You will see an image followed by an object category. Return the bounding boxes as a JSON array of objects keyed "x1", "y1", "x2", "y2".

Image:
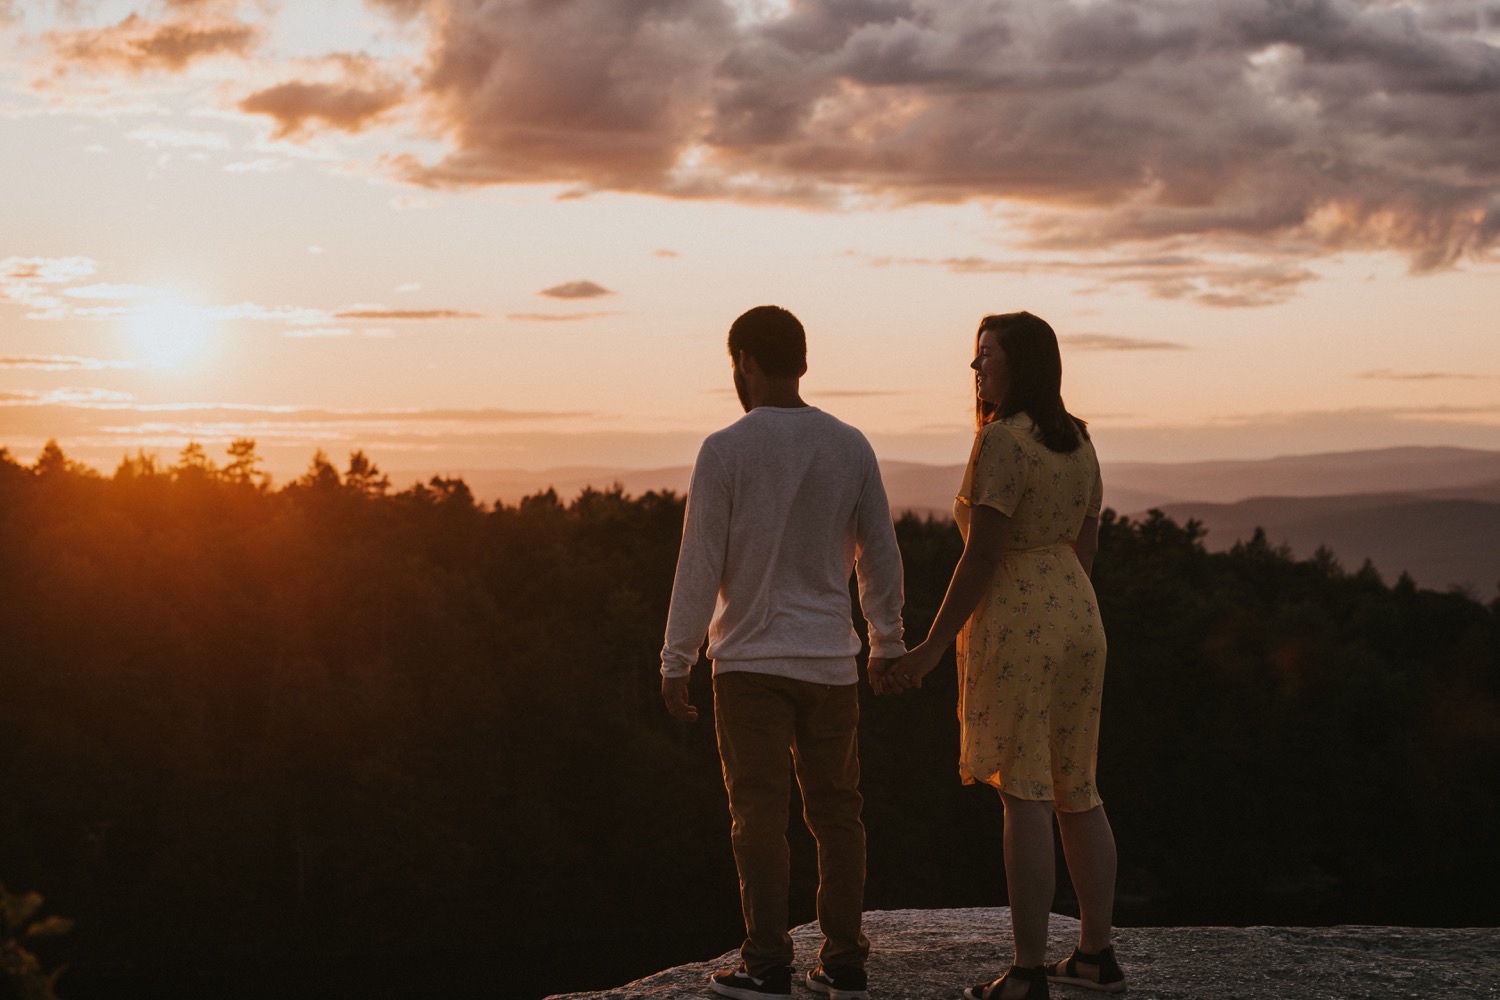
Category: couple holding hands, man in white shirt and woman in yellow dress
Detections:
[{"x1": 662, "y1": 306, "x2": 1125, "y2": 1000}]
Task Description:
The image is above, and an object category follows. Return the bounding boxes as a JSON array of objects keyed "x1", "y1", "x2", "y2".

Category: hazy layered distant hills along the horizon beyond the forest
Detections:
[{"x1": 392, "y1": 447, "x2": 1500, "y2": 600}]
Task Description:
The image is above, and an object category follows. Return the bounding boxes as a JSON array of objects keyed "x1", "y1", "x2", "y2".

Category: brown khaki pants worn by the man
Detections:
[{"x1": 714, "y1": 672, "x2": 870, "y2": 978}]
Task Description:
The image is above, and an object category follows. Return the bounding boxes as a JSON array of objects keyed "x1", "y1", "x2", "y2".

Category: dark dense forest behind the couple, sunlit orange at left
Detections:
[{"x1": 0, "y1": 441, "x2": 1500, "y2": 1000}]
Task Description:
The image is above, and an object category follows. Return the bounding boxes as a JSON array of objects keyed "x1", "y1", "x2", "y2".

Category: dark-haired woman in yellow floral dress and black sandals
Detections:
[{"x1": 876, "y1": 312, "x2": 1125, "y2": 1000}]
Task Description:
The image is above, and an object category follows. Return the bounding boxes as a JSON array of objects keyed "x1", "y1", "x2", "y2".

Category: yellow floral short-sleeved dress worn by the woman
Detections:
[{"x1": 954, "y1": 414, "x2": 1106, "y2": 813}]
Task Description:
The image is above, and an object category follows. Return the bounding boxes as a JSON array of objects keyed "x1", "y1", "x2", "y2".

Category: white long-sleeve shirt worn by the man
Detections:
[{"x1": 662, "y1": 406, "x2": 906, "y2": 684}]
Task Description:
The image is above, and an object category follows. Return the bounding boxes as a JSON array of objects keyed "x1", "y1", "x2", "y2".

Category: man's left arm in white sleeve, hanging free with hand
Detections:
[{"x1": 662, "y1": 442, "x2": 729, "y2": 723}]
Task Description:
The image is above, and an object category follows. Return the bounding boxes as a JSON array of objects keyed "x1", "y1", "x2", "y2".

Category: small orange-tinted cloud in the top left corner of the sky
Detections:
[{"x1": 47, "y1": 11, "x2": 261, "y2": 75}]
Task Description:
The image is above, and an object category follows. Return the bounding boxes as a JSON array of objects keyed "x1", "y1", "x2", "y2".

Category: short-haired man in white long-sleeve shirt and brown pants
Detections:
[{"x1": 662, "y1": 306, "x2": 905, "y2": 1000}]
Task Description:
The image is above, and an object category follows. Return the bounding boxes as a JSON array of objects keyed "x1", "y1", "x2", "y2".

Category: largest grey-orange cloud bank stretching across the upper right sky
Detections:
[{"x1": 366, "y1": 0, "x2": 1500, "y2": 280}]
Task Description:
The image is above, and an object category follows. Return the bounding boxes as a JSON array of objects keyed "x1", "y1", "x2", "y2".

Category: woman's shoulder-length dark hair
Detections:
[{"x1": 974, "y1": 312, "x2": 1089, "y2": 451}]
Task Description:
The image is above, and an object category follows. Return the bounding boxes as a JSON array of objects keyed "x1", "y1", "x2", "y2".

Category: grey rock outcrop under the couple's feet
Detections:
[{"x1": 549, "y1": 907, "x2": 1500, "y2": 1000}]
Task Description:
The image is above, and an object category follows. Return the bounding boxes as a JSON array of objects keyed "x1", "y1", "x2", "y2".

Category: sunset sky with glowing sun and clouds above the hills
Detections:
[{"x1": 0, "y1": 0, "x2": 1500, "y2": 481}]
